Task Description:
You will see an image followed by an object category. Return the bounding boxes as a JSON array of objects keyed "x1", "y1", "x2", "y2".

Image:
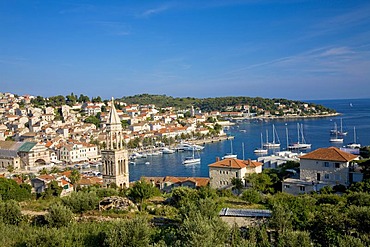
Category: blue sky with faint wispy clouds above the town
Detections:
[{"x1": 0, "y1": 0, "x2": 370, "y2": 99}]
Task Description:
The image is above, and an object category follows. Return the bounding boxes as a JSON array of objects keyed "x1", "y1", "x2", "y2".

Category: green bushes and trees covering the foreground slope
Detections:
[{"x1": 0, "y1": 163, "x2": 370, "y2": 247}]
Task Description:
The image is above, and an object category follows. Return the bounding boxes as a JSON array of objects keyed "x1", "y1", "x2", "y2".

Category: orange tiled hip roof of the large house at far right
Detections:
[{"x1": 300, "y1": 147, "x2": 357, "y2": 162}]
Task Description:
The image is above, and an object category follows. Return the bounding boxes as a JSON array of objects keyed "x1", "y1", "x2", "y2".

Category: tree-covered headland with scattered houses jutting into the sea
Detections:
[{"x1": 120, "y1": 94, "x2": 338, "y2": 117}]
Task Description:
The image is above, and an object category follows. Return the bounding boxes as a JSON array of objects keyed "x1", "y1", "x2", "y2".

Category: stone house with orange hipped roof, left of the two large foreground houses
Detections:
[{"x1": 208, "y1": 158, "x2": 262, "y2": 189}]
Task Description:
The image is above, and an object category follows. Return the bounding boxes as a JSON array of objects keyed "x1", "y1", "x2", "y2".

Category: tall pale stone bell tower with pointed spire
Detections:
[{"x1": 101, "y1": 98, "x2": 129, "y2": 188}]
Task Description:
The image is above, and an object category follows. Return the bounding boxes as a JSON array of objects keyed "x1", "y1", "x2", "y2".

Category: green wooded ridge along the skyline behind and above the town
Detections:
[{"x1": 26, "y1": 93, "x2": 336, "y2": 116}]
